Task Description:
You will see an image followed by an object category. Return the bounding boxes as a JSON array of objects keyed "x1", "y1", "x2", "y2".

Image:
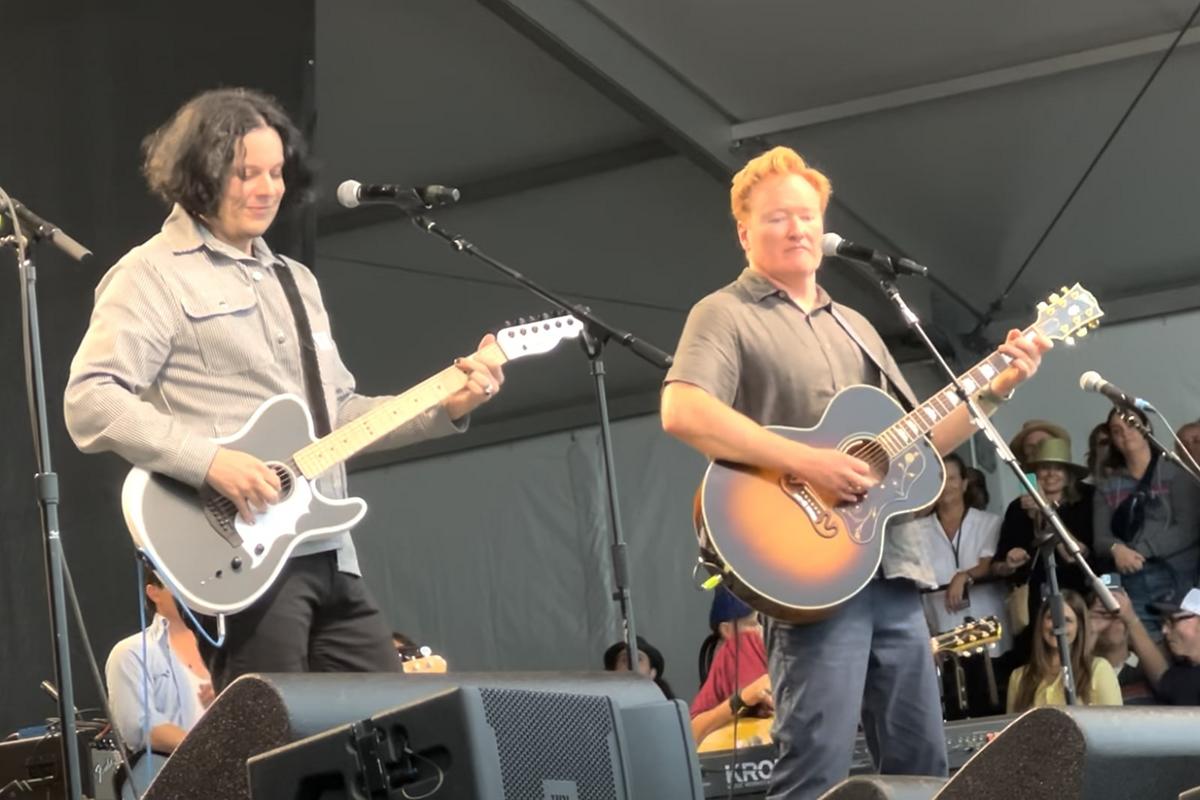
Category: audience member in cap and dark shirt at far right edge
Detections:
[{"x1": 1114, "y1": 588, "x2": 1200, "y2": 705}]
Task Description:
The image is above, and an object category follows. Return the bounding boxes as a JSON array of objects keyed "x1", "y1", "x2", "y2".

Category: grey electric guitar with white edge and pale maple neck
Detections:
[{"x1": 121, "y1": 315, "x2": 583, "y2": 615}]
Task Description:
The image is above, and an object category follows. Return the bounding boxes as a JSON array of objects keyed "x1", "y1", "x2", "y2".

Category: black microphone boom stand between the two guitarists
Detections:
[{"x1": 404, "y1": 207, "x2": 672, "y2": 672}]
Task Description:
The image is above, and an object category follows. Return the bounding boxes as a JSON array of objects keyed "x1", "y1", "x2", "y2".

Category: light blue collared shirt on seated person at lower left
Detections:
[{"x1": 104, "y1": 614, "x2": 204, "y2": 752}]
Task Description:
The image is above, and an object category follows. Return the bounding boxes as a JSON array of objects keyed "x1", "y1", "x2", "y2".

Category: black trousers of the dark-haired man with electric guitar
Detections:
[{"x1": 198, "y1": 552, "x2": 401, "y2": 692}]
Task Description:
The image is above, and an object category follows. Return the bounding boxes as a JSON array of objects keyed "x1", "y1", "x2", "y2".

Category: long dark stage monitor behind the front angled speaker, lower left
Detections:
[{"x1": 144, "y1": 673, "x2": 664, "y2": 800}]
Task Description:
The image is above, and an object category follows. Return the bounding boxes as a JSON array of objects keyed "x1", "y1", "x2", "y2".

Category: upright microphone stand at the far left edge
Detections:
[{"x1": 0, "y1": 191, "x2": 83, "y2": 800}]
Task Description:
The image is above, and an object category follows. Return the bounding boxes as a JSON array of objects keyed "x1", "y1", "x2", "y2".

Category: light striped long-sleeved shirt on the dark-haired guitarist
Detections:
[{"x1": 65, "y1": 205, "x2": 462, "y2": 575}]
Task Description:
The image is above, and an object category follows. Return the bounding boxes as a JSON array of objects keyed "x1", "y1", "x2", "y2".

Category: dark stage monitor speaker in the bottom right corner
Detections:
[{"x1": 937, "y1": 705, "x2": 1200, "y2": 800}]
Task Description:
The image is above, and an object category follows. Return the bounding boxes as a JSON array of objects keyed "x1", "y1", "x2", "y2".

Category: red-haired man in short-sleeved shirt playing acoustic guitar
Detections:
[{"x1": 662, "y1": 148, "x2": 1050, "y2": 800}]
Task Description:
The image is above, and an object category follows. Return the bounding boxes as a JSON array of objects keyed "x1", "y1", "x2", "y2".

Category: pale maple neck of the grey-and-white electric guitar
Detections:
[{"x1": 293, "y1": 344, "x2": 508, "y2": 480}]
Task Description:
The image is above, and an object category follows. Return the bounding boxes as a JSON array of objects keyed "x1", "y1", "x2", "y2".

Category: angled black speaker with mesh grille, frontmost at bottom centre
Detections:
[{"x1": 247, "y1": 687, "x2": 703, "y2": 800}]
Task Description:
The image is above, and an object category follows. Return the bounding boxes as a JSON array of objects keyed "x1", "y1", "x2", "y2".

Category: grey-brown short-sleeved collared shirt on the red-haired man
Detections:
[{"x1": 664, "y1": 267, "x2": 937, "y2": 588}]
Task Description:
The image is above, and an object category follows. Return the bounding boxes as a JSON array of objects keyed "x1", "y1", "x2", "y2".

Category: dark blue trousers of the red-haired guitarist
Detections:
[{"x1": 766, "y1": 579, "x2": 947, "y2": 800}]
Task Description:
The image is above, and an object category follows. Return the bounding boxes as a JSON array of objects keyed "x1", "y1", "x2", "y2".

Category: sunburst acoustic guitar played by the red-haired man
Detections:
[{"x1": 694, "y1": 283, "x2": 1104, "y2": 622}]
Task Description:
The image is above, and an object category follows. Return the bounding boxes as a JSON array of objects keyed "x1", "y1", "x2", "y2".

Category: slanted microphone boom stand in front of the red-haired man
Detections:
[{"x1": 871, "y1": 264, "x2": 1120, "y2": 705}]
